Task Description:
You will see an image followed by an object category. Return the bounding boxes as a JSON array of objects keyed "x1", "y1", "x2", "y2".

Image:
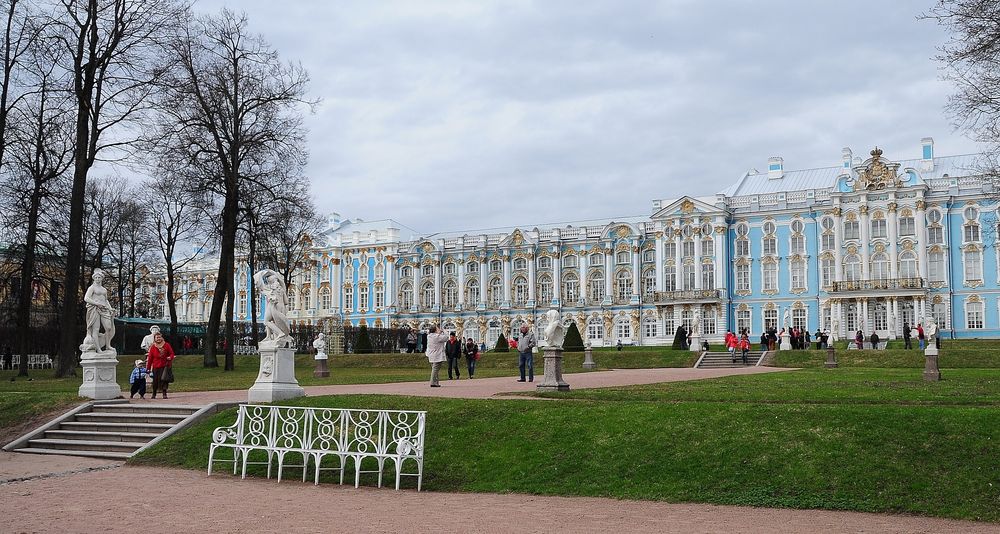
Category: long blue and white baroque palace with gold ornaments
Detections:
[{"x1": 162, "y1": 138, "x2": 1000, "y2": 345}]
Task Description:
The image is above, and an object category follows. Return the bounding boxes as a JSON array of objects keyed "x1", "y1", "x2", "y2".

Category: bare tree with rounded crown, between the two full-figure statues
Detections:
[{"x1": 154, "y1": 10, "x2": 311, "y2": 367}]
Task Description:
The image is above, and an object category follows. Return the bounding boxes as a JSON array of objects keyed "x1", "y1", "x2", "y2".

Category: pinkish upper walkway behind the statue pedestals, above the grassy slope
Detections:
[{"x1": 132, "y1": 367, "x2": 789, "y2": 405}]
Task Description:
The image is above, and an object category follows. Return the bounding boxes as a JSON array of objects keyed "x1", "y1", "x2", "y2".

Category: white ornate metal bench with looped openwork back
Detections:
[{"x1": 208, "y1": 404, "x2": 427, "y2": 491}]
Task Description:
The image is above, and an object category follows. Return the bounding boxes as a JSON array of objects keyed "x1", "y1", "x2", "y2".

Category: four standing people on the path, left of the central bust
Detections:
[{"x1": 422, "y1": 325, "x2": 538, "y2": 388}]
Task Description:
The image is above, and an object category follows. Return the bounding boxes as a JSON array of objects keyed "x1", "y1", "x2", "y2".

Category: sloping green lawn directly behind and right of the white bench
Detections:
[{"x1": 132, "y1": 369, "x2": 1000, "y2": 521}]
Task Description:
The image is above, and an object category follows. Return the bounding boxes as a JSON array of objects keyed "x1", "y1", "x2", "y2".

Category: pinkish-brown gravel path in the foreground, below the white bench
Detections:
[{"x1": 0, "y1": 462, "x2": 1000, "y2": 534}]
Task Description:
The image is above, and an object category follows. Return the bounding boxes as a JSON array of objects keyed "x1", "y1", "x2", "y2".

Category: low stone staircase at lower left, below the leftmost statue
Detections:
[{"x1": 4, "y1": 402, "x2": 215, "y2": 460}]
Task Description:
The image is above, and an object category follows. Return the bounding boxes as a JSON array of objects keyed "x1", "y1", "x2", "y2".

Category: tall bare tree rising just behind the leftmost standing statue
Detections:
[{"x1": 46, "y1": 0, "x2": 186, "y2": 376}]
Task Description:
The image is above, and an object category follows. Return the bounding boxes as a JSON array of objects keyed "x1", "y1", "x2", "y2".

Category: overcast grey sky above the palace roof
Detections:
[{"x1": 198, "y1": 0, "x2": 977, "y2": 233}]
